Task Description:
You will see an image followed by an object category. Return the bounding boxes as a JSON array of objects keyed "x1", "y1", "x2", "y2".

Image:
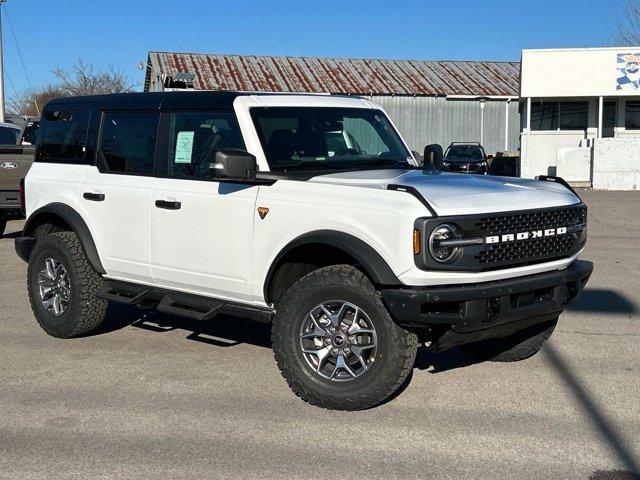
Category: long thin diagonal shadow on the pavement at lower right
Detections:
[{"x1": 542, "y1": 343, "x2": 640, "y2": 480}]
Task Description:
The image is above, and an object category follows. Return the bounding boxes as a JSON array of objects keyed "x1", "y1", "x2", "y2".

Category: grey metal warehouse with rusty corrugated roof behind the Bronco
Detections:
[{"x1": 144, "y1": 52, "x2": 520, "y2": 153}]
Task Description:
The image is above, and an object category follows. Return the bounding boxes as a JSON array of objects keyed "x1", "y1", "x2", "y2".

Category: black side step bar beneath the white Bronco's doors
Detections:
[{"x1": 98, "y1": 280, "x2": 275, "y2": 323}]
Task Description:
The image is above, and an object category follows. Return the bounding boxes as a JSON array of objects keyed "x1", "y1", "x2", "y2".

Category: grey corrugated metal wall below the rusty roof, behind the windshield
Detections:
[{"x1": 367, "y1": 96, "x2": 520, "y2": 154}]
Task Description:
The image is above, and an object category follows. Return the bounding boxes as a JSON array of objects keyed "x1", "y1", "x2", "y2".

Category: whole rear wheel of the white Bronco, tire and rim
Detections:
[{"x1": 27, "y1": 232, "x2": 107, "y2": 338}]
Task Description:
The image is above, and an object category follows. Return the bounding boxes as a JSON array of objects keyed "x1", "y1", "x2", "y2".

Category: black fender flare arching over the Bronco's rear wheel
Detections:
[{"x1": 23, "y1": 203, "x2": 106, "y2": 274}]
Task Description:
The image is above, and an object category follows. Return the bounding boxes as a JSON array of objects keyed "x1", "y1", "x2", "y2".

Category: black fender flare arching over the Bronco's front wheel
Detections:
[{"x1": 263, "y1": 230, "x2": 402, "y2": 298}]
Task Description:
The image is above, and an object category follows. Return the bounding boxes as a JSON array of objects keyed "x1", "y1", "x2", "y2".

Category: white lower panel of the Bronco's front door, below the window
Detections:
[{"x1": 150, "y1": 178, "x2": 259, "y2": 302}]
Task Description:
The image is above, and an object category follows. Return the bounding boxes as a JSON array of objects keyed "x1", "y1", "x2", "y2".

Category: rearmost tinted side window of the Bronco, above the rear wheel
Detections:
[{"x1": 38, "y1": 110, "x2": 91, "y2": 163}]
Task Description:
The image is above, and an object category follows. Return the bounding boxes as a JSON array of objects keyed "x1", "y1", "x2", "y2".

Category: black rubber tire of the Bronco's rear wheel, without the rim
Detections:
[{"x1": 27, "y1": 232, "x2": 108, "y2": 338}]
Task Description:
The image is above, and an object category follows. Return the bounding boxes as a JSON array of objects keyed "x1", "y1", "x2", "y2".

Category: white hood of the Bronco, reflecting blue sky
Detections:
[{"x1": 309, "y1": 170, "x2": 580, "y2": 216}]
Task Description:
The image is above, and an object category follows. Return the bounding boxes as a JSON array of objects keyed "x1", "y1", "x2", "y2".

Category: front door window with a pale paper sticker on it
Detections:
[{"x1": 167, "y1": 112, "x2": 245, "y2": 178}]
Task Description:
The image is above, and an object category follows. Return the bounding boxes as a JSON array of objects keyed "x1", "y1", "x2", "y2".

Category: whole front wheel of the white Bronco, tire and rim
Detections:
[{"x1": 272, "y1": 265, "x2": 418, "y2": 410}]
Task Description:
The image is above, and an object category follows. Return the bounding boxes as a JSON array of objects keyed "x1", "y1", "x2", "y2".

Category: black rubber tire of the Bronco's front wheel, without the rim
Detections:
[{"x1": 271, "y1": 265, "x2": 418, "y2": 410}]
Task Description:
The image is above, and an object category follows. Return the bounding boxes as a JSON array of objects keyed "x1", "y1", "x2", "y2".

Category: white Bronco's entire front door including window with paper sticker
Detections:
[{"x1": 150, "y1": 111, "x2": 258, "y2": 301}]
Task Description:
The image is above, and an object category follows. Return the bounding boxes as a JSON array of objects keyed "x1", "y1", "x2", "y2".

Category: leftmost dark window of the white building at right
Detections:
[{"x1": 531, "y1": 102, "x2": 589, "y2": 131}]
